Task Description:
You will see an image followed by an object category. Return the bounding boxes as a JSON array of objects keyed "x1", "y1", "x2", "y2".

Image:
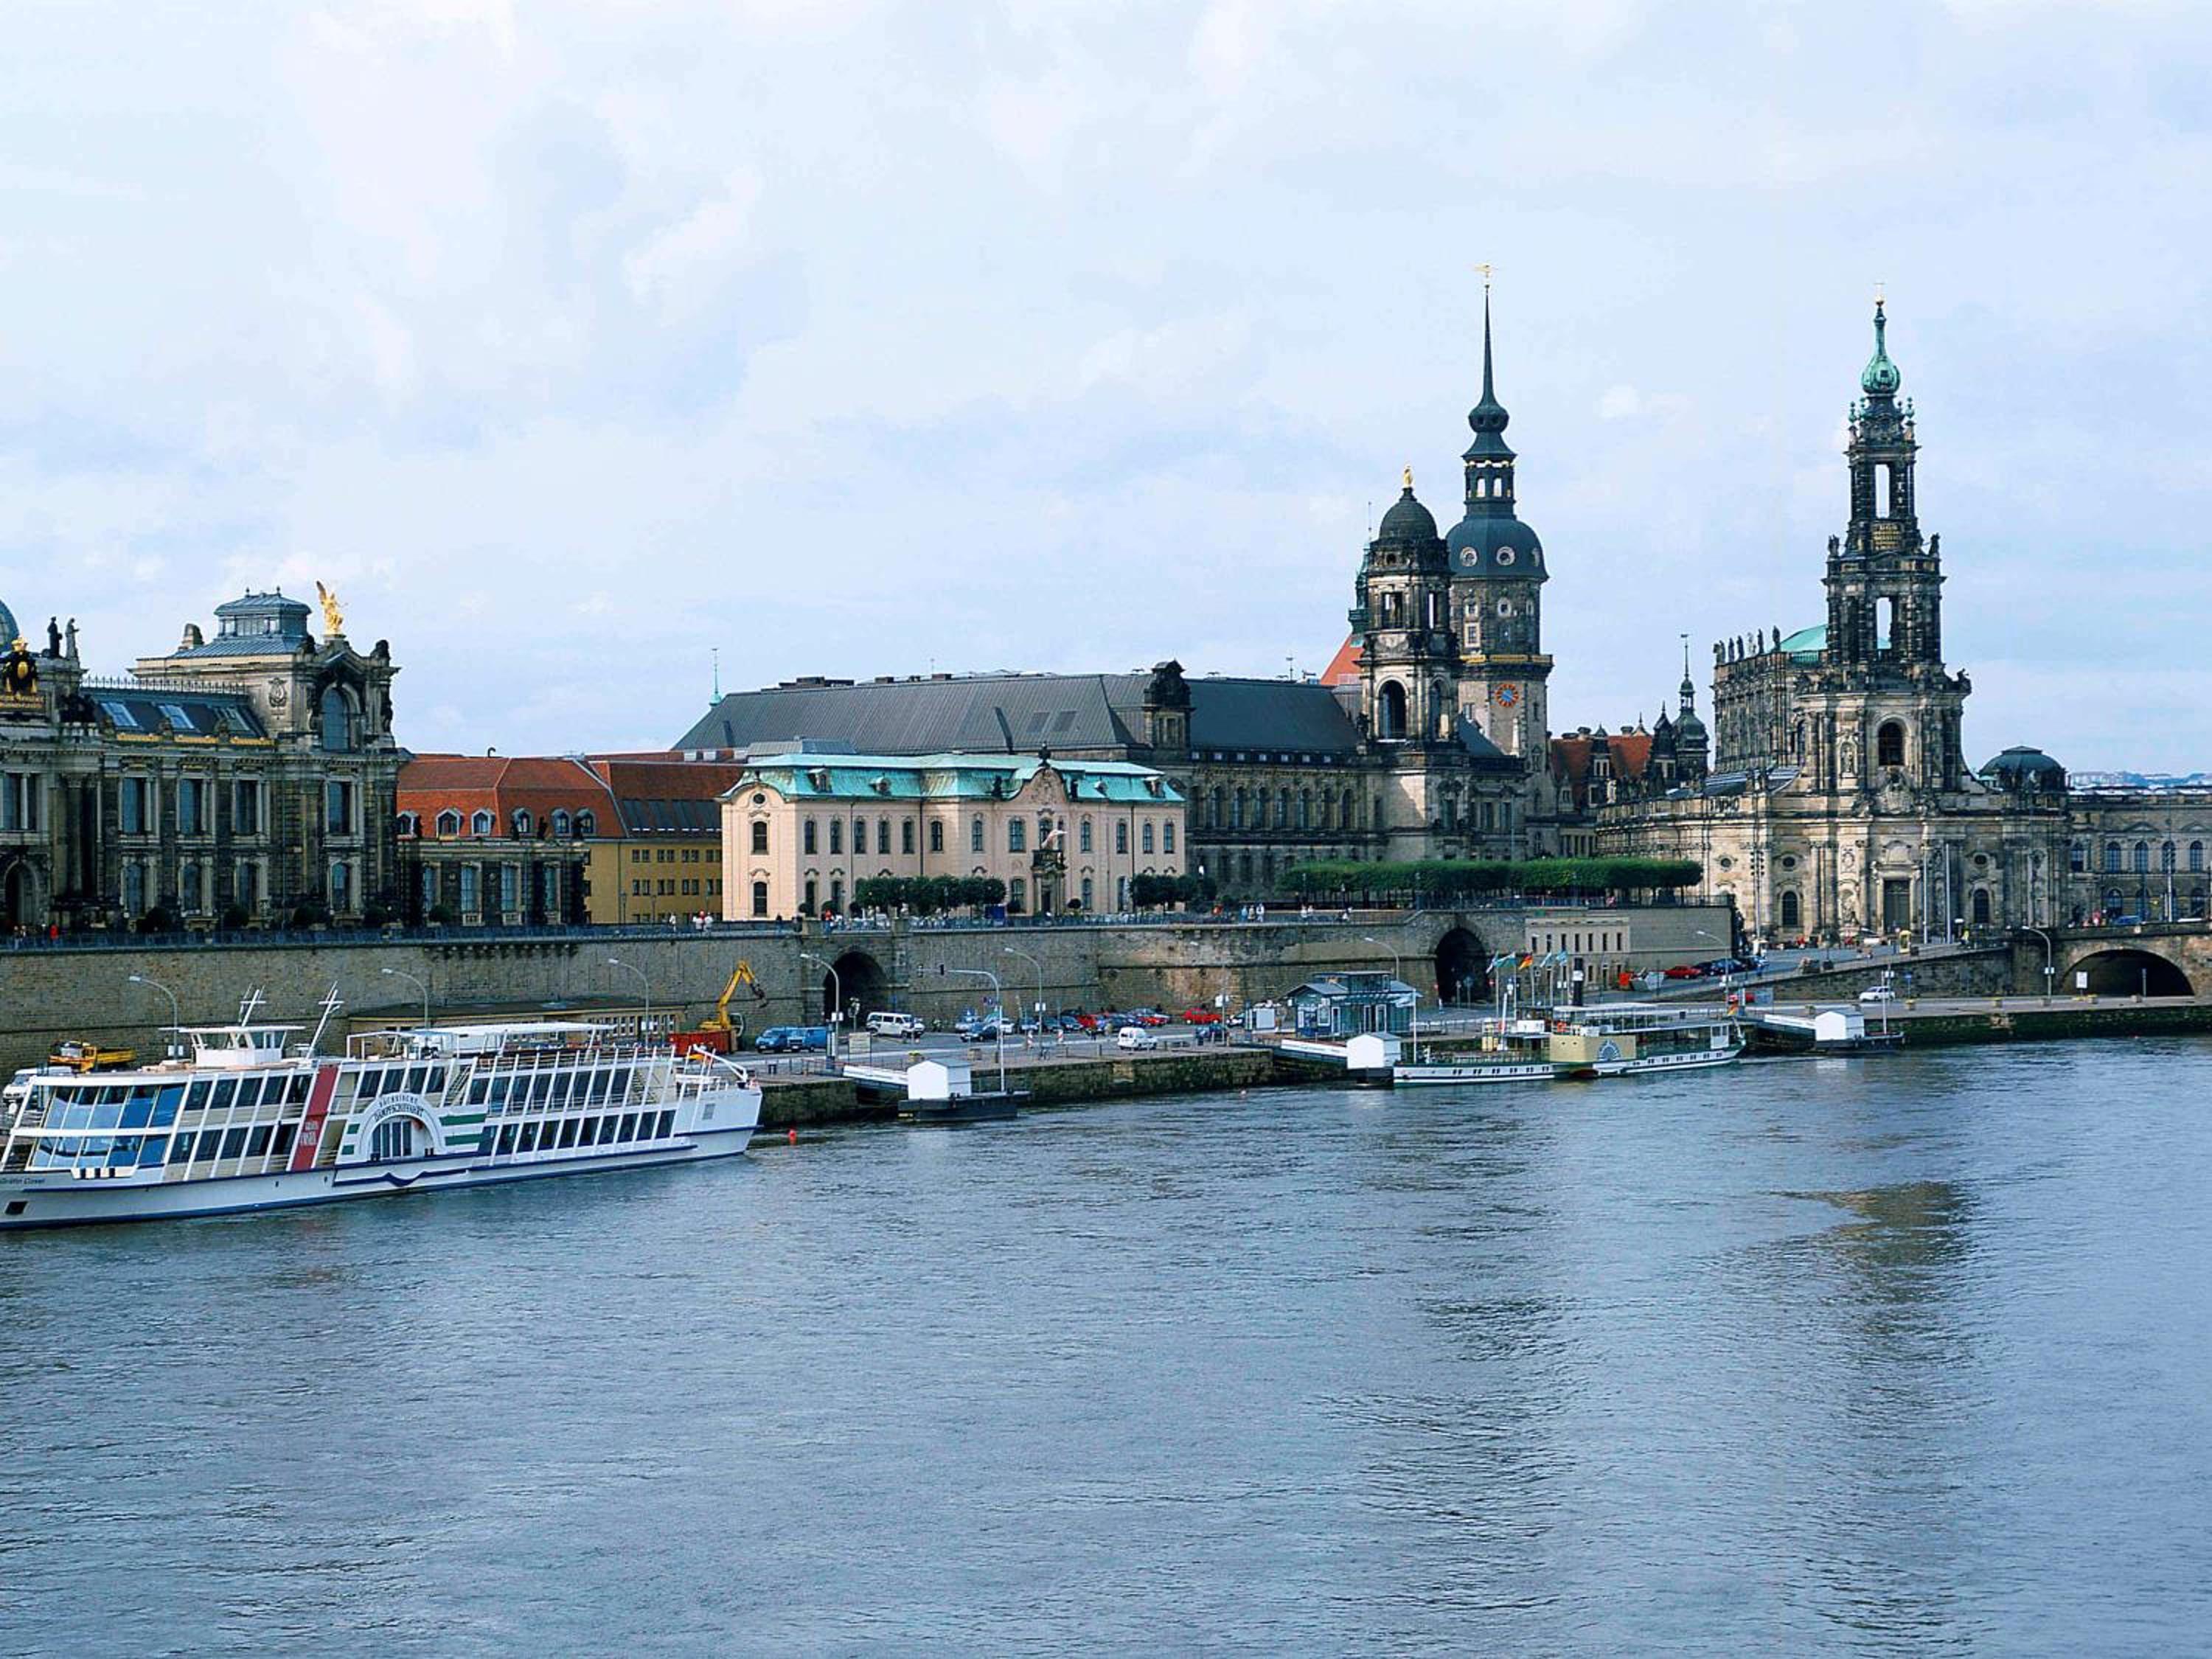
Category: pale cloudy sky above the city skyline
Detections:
[{"x1": 0, "y1": 0, "x2": 2212, "y2": 770}]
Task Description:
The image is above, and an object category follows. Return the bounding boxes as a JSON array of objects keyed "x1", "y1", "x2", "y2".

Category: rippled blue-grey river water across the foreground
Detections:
[{"x1": 0, "y1": 1042, "x2": 2212, "y2": 1655}]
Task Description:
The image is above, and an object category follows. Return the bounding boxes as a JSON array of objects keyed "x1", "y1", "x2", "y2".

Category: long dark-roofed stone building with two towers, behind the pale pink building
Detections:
[{"x1": 675, "y1": 292, "x2": 1566, "y2": 896}]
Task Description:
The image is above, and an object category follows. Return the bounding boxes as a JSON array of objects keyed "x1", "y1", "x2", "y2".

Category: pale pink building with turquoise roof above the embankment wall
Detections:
[{"x1": 721, "y1": 752, "x2": 1188, "y2": 920}]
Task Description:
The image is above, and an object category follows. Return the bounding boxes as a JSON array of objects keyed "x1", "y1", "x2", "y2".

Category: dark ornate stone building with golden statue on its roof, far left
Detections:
[{"x1": 0, "y1": 593, "x2": 398, "y2": 931}]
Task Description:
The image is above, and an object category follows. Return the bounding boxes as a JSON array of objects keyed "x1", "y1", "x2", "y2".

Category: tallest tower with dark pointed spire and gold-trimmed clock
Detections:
[{"x1": 1444, "y1": 285, "x2": 1551, "y2": 763}]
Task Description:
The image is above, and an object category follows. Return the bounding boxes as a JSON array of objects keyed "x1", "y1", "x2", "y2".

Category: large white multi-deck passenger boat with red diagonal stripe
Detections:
[{"x1": 0, "y1": 1013, "x2": 761, "y2": 1230}]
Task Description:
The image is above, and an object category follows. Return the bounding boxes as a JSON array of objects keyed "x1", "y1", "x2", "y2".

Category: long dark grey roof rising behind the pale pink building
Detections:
[{"x1": 675, "y1": 675, "x2": 1358, "y2": 754}]
